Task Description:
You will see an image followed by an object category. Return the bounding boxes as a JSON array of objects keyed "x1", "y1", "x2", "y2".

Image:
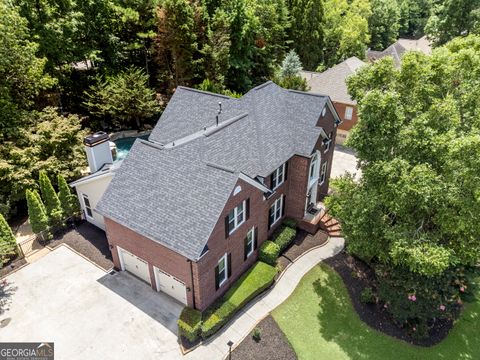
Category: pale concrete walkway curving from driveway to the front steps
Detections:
[{"x1": 184, "y1": 238, "x2": 344, "y2": 360}]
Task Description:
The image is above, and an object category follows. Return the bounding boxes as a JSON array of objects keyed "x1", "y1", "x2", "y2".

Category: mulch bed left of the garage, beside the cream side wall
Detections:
[{"x1": 48, "y1": 222, "x2": 113, "y2": 270}]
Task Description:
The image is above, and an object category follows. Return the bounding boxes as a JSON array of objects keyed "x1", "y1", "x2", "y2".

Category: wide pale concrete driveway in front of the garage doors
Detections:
[{"x1": 0, "y1": 246, "x2": 182, "y2": 359}]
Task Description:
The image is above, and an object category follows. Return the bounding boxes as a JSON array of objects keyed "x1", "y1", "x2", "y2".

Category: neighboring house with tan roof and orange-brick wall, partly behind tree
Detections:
[{"x1": 301, "y1": 56, "x2": 365, "y2": 144}]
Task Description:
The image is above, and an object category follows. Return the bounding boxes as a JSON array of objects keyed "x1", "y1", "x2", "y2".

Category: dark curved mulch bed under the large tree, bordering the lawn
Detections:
[{"x1": 323, "y1": 251, "x2": 453, "y2": 346}]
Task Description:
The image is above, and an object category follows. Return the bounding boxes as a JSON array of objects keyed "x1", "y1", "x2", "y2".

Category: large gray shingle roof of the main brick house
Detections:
[{"x1": 96, "y1": 82, "x2": 328, "y2": 260}]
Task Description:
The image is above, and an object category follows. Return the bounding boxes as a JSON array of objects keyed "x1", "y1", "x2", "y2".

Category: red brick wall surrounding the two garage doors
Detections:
[{"x1": 105, "y1": 218, "x2": 193, "y2": 306}]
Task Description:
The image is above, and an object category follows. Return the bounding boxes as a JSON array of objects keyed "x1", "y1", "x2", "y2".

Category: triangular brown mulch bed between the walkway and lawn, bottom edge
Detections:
[{"x1": 232, "y1": 316, "x2": 297, "y2": 360}]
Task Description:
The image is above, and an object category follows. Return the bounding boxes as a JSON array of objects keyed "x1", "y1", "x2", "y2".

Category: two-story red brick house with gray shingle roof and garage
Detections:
[{"x1": 73, "y1": 82, "x2": 340, "y2": 310}]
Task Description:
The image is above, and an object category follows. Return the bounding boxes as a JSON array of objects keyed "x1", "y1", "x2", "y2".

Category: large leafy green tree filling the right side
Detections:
[{"x1": 328, "y1": 36, "x2": 480, "y2": 334}]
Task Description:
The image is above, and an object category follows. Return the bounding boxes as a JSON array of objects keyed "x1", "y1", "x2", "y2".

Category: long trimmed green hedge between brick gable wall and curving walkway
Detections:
[{"x1": 201, "y1": 261, "x2": 277, "y2": 339}]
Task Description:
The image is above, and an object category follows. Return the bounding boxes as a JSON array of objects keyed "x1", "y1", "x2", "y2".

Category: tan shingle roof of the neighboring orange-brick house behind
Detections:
[{"x1": 301, "y1": 56, "x2": 365, "y2": 105}]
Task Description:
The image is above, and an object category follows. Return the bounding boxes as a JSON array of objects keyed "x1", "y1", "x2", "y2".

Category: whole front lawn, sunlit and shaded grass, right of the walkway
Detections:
[{"x1": 272, "y1": 264, "x2": 480, "y2": 360}]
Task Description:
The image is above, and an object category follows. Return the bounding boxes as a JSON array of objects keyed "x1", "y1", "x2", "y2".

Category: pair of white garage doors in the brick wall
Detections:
[{"x1": 117, "y1": 247, "x2": 187, "y2": 304}]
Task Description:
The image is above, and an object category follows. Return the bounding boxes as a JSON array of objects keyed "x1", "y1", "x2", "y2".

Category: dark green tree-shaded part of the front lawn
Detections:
[{"x1": 313, "y1": 265, "x2": 480, "y2": 360}]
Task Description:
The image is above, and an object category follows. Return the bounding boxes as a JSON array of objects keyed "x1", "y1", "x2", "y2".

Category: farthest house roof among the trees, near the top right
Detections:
[{"x1": 366, "y1": 36, "x2": 432, "y2": 67}]
